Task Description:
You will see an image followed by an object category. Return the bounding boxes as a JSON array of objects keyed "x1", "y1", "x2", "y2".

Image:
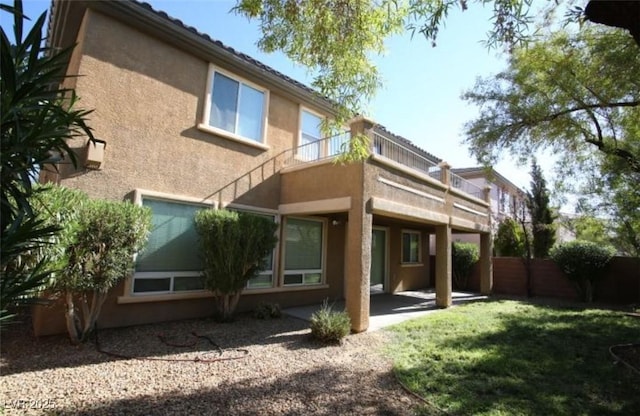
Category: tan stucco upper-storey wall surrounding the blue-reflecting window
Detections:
[{"x1": 57, "y1": 10, "x2": 312, "y2": 208}]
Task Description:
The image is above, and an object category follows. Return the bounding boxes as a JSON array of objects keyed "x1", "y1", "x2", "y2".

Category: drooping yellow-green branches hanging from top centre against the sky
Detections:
[{"x1": 233, "y1": 0, "x2": 532, "y2": 125}]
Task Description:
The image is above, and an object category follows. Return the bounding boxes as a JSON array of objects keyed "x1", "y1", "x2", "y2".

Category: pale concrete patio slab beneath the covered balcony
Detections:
[{"x1": 283, "y1": 289, "x2": 487, "y2": 331}]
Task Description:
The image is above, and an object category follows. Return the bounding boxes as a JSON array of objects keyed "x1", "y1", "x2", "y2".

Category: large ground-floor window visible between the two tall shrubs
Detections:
[{"x1": 132, "y1": 196, "x2": 209, "y2": 294}]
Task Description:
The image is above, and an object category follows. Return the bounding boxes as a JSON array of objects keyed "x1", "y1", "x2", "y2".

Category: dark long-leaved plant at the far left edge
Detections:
[{"x1": 0, "y1": 1, "x2": 93, "y2": 322}]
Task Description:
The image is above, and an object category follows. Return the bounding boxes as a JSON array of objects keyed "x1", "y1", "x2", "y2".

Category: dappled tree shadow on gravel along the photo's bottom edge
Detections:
[{"x1": 51, "y1": 366, "x2": 415, "y2": 416}]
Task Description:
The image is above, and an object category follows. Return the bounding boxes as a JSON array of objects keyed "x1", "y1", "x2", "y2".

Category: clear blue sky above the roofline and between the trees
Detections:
[{"x1": 12, "y1": 0, "x2": 549, "y2": 188}]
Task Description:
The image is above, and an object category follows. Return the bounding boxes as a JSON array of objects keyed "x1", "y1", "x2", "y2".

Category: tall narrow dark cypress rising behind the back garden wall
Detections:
[{"x1": 526, "y1": 160, "x2": 557, "y2": 258}]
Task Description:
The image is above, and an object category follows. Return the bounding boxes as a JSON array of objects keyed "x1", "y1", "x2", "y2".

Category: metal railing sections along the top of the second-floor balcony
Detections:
[{"x1": 284, "y1": 132, "x2": 483, "y2": 199}]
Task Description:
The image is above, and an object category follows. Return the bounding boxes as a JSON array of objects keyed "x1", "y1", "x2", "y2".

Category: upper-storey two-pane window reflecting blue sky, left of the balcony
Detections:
[{"x1": 208, "y1": 67, "x2": 267, "y2": 143}]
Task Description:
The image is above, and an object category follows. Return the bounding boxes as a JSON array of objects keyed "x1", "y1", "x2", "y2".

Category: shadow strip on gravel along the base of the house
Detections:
[{"x1": 0, "y1": 315, "x2": 322, "y2": 375}]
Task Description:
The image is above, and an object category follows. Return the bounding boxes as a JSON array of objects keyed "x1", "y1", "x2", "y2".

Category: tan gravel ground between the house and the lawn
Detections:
[{"x1": 0, "y1": 316, "x2": 419, "y2": 415}]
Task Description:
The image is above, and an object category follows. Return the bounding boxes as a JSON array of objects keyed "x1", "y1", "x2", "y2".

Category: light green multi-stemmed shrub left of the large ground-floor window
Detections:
[{"x1": 40, "y1": 186, "x2": 151, "y2": 343}]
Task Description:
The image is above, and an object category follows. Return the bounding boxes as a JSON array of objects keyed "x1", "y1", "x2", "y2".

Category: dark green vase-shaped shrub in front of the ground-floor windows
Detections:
[{"x1": 195, "y1": 210, "x2": 278, "y2": 320}]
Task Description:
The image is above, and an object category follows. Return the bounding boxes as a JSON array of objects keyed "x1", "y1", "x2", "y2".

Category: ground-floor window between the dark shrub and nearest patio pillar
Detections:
[{"x1": 283, "y1": 218, "x2": 324, "y2": 286}]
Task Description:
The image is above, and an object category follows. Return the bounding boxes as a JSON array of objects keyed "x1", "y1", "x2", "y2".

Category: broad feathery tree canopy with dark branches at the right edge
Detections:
[{"x1": 463, "y1": 27, "x2": 640, "y2": 172}]
